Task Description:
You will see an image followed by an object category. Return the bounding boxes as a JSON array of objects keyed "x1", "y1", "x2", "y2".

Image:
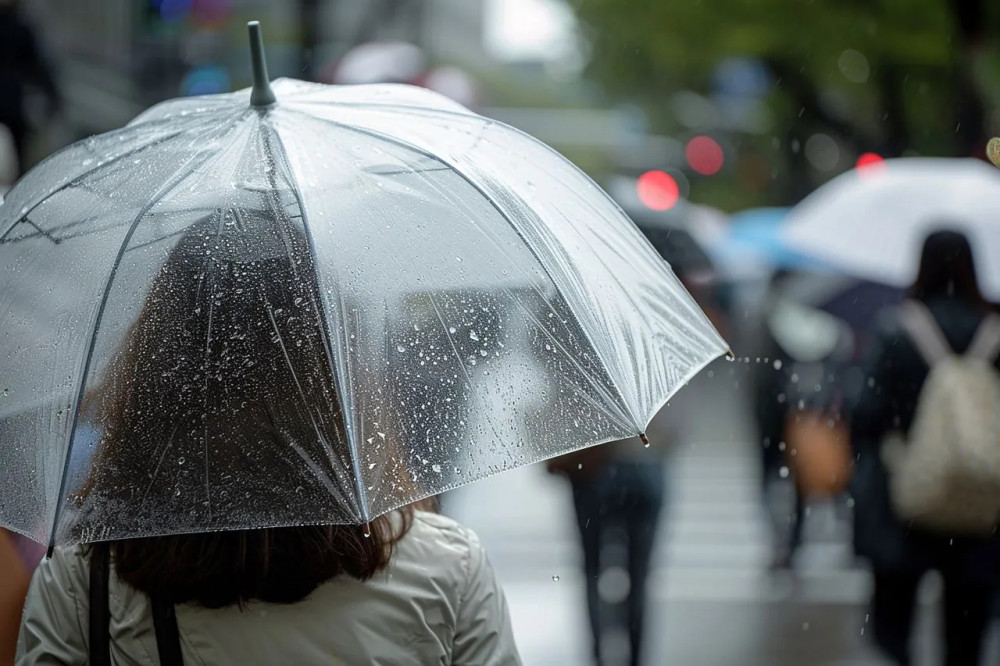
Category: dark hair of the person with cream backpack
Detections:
[{"x1": 910, "y1": 226, "x2": 986, "y2": 306}]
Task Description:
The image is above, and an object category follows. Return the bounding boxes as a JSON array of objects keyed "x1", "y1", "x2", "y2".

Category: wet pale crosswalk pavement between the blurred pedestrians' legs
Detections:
[{"x1": 444, "y1": 362, "x2": 1000, "y2": 666}]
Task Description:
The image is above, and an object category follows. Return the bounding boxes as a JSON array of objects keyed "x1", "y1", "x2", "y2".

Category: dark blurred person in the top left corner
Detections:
[{"x1": 0, "y1": 0, "x2": 60, "y2": 175}]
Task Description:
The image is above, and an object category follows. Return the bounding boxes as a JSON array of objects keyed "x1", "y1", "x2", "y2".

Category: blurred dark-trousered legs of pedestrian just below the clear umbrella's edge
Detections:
[{"x1": 548, "y1": 439, "x2": 666, "y2": 666}]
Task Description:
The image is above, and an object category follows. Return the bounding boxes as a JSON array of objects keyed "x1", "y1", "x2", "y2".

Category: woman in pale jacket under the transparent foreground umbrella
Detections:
[{"x1": 17, "y1": 216, "x2": 520, "y2": 666}]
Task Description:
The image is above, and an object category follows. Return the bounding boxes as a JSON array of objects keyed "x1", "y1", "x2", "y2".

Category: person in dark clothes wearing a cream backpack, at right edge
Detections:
[{"x1": 851, "y1": 231, "x2": 1000, "y2": 666}]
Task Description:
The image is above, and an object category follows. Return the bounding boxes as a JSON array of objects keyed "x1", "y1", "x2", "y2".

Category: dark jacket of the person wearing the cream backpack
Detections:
[{"x1": 851, "y1": 296, "x2": 1000, "y2": 582}]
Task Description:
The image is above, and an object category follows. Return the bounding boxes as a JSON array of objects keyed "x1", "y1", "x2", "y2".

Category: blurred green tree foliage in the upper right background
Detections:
[{"x1": 571, "y1": 0, "x2": 1000, "y2": 200}]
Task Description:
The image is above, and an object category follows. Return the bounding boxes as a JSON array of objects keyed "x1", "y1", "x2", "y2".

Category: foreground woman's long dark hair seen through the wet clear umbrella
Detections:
[{"x1": 71, "y1": 208, "x2": 426, "y2": 608}]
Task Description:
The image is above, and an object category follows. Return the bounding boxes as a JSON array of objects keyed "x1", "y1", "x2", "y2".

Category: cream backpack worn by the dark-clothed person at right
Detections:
[{"x1": 883, "y1": 301, "x2": 1000, "y2": 535}]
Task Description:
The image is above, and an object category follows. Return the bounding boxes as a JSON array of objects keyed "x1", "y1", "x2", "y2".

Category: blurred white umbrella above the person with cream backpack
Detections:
[{"x1": 782, "y1": 158, "x2": 1000, "y2": 299}]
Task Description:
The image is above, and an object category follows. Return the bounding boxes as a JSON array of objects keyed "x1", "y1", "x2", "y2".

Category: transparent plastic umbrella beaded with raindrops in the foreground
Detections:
[{"x1": 0, "y1": 23, "x2": 726, "y2": 544}]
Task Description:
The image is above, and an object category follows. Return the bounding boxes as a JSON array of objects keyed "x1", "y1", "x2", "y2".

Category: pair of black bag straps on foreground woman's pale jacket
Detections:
[{"x1": 89, "y1": 548, "x2": 184, "y2": 666}]
